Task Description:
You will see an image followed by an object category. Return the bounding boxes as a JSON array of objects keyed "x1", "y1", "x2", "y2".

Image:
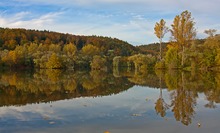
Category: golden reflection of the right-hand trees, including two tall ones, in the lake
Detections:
[{"x1": 113, "y1": 70, "x2": 220, "y2": 125}]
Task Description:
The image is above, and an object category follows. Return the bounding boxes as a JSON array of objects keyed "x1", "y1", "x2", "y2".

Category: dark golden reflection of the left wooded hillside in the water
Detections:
[{"x1": 0, "y1": 70, "x2": 134, "y2": 106}]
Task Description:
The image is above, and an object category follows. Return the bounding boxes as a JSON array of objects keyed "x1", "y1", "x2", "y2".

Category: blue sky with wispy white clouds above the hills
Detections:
[{"x1": 0, "y1": 0, "x2": 220, "y2": 45}]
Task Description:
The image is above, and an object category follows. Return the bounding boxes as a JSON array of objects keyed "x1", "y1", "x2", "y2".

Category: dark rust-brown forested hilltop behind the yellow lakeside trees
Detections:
[{"x1": 0, "y1": 28, "x2": 139, "y2": 56}]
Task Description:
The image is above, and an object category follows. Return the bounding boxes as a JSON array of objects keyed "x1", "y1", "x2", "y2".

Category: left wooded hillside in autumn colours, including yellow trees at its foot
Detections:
[{"x1": 0, "y1": 28, "x2": 138, "y2": 69}]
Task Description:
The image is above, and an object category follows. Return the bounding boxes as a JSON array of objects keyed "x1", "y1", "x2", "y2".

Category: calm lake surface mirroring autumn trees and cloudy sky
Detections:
[{"x1": 0, "y1": 70, "x2": 220, "y2": 133}]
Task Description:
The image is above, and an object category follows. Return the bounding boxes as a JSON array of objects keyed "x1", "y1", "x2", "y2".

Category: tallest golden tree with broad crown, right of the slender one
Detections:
[{"x1": 170, "y1": 11, "x2": 196, "y2": 66}]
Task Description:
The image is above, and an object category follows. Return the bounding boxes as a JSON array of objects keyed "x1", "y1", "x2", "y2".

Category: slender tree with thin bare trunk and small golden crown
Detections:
[{"x1": 154, "y1": 19, "x2": 168, "y2": 61}]
